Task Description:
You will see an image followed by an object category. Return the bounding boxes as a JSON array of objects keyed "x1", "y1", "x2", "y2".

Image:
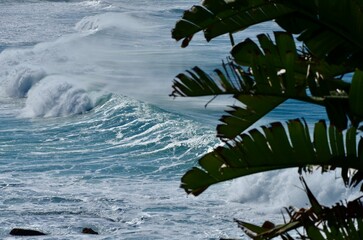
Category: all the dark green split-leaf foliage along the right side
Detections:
[{"x1": 171, "y1": 0, "x2": 363, "y2": 239}]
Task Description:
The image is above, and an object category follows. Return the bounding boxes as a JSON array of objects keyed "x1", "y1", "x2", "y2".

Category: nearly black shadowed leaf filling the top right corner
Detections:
[{"x1": 276, "y1": 0, "x2": 363, "y2": 66}]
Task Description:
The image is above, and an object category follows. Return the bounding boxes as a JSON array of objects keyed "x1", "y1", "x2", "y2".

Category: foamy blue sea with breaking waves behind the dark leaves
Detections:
[{"x1": 0, "y1": 0, "x2": 354, "y2": 239}]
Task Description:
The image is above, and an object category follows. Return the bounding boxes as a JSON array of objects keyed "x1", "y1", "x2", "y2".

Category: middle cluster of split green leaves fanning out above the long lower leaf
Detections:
[{"x1": 171, "y1": 32, "x2": 350, "y2": 139}]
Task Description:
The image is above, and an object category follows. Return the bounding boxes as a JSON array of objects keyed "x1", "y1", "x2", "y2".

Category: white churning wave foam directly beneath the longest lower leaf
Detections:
[{"x1": 229, "y1": 169, "x2": 357, "y2": 211}]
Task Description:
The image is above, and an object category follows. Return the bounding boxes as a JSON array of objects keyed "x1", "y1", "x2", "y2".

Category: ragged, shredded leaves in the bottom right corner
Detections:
[{"x1": 235, "y1": 181, "x2": 363, "y2": 240}]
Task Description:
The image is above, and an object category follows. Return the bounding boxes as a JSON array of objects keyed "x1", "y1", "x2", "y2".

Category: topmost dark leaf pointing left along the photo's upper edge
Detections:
[{"x1": 172, "y1": 0, "x2": 294, "y2": 41}]
